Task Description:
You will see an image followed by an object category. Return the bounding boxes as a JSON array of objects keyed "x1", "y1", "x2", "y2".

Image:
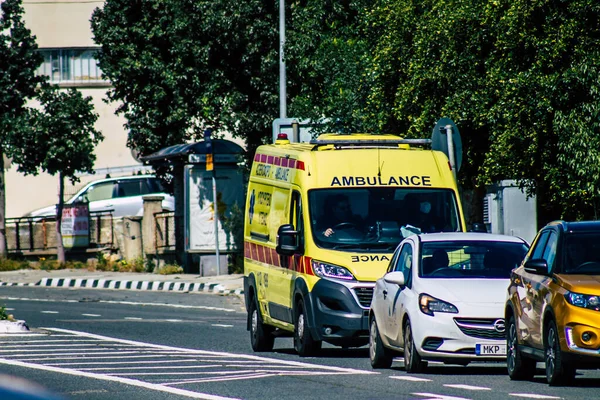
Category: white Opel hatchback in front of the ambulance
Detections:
[{"x1": 369, "y1": 233, "x2": 529, "y2": 373}]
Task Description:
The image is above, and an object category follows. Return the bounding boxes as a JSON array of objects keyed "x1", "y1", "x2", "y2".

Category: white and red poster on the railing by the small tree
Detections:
[{"x1": 60, "y1": 203, "x2": 90, "y2": 248}]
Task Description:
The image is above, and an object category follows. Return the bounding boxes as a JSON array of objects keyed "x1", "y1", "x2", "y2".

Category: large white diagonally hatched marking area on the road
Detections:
[{"x1": 0, "y1": 328, "x2": 378, "y2": 399}]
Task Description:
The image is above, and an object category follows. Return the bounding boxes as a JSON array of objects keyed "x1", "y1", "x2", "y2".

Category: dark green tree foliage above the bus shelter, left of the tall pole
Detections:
[{"x1": 92, "y1": 0, "x2": 278, "y2": 162}]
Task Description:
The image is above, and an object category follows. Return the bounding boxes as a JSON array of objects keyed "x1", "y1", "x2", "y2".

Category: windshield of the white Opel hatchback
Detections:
[{"x1": 419, "y1": 241, "x2": 527, "y2": 279}]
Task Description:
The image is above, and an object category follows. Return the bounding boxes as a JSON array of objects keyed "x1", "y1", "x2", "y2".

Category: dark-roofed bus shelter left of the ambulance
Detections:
[{"x1": 142, "y1": 139, "x2": 245, "y2": 276}]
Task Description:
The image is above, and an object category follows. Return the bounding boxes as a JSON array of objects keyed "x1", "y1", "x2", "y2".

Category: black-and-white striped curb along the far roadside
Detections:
[{"x1": 0, "y1": 278, "x2": 244, "y2": 295}]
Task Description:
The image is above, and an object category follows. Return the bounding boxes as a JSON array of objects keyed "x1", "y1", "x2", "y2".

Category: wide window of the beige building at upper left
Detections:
[{"x1": 37, "y1": 48, "x2": 103, "y2": 84}]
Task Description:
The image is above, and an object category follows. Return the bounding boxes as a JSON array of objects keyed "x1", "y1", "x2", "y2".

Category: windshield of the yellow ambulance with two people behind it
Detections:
[{"x1": 308, "y1": 187, "x2": 461, "y2": 252}]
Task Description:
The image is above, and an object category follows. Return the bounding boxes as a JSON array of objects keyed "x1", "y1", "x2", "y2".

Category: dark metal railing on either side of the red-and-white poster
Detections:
[{"x1": 5, "y1": 211, "x2": 115, "y2": 253}]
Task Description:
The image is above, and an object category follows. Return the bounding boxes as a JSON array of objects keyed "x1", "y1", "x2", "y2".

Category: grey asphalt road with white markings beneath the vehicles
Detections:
[{"x1": 0, "y1": 287, "x2": 600, "y2": 400}]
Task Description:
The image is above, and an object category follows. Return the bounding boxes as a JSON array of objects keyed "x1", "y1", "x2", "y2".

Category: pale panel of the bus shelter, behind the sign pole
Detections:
[{"x1": 185, "y1": 165, "x2": 244, "y2": 252}]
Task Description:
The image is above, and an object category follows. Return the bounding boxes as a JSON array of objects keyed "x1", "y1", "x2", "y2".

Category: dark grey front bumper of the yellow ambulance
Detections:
[{"x1": 310, "y1": 279, "x2": 375, "y2": 347}]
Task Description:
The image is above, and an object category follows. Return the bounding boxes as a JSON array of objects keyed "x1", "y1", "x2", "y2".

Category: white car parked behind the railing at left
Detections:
[{"x1": 26, "y1": 175, "x2": 175, "y2": 217}]
